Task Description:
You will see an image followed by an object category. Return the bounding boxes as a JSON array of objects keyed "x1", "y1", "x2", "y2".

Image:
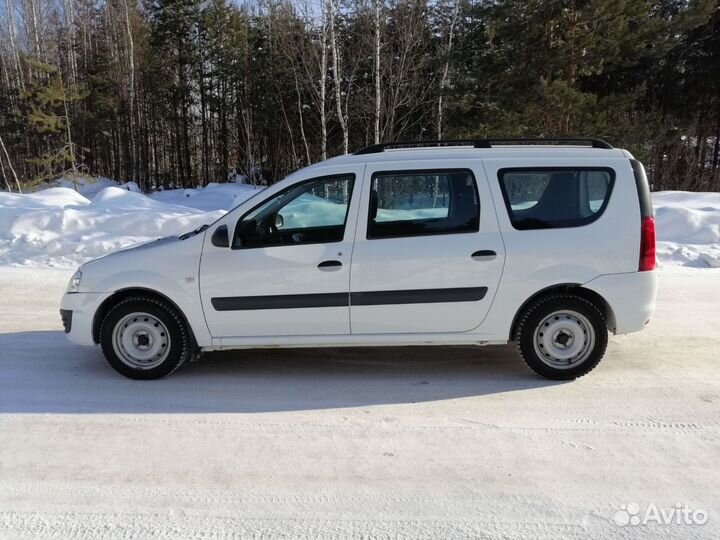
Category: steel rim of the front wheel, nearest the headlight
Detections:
[{"x1": 112, "y1": 312, "x2": 170, "y2": 369}]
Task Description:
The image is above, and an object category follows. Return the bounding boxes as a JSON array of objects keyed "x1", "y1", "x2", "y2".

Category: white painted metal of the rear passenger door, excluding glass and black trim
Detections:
[{"x1": 350, "y1": 159, "x2": 505, "y2": 339}]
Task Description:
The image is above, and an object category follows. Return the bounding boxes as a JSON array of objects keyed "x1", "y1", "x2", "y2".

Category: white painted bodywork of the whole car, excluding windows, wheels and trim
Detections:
[{"x1": 61, "y1": 146, "x2": 657, "y2": 350}]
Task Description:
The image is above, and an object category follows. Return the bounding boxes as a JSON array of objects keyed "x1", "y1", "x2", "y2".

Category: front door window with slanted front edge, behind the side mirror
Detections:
[{"x1": 233, "y1": 174, "x2": 355, "y2": 249}]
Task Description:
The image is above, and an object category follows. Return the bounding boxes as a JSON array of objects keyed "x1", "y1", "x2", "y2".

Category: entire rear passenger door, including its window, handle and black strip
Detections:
[{"x1": 350, "y1": 160, "x2": 505, "y2": 334}]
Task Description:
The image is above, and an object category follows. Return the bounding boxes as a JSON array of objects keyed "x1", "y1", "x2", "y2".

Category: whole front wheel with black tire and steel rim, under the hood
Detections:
[{"x1": 100, "y1": 296, "x2": 191, "y2": 380}]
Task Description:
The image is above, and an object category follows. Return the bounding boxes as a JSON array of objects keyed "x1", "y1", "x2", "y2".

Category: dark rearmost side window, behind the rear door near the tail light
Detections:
[{"x1": 498, "y1": 167, "x2": 615, "y2": 230}]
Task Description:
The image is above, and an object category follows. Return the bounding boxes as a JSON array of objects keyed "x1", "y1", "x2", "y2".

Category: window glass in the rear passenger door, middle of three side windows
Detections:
[{"x1": 367, "y1": 169, "x2": 480, "y2": 239}]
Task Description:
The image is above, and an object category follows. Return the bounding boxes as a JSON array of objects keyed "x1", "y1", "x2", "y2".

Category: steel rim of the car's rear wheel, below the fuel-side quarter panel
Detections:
[{"x1": 533, "y1": 310, "x2": 595, "y2": 369}]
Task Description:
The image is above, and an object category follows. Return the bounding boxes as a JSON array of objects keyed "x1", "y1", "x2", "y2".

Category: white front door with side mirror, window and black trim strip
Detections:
[{"x1": 200, "y1": 166, "x2": 362, "y2": 338}]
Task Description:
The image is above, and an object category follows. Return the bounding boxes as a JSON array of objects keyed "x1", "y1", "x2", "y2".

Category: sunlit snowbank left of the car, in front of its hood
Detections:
[{"x1": 0, "y1": 181, "x2": 257, "y2": 267}]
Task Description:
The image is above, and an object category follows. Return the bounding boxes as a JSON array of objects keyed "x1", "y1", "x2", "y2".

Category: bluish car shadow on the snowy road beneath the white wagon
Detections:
[{"x1": 0, "y1": 331, "x2": 562, "y2": 413}]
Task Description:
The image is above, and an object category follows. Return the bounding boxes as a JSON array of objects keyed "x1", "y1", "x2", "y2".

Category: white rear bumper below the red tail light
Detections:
[{"x1": 583, "y1": 271, "x2": 658, "y2": 334}]
